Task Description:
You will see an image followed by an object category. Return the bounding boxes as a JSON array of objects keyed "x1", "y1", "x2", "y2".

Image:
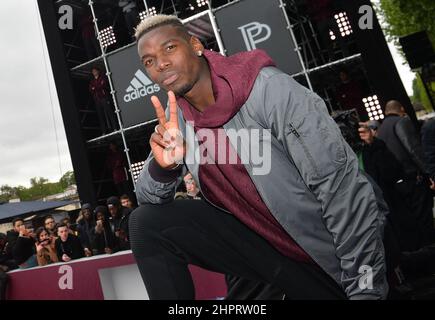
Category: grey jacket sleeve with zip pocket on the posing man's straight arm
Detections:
[{"x1": 255, "y1": 73, "x2": 388, "y2": 299}]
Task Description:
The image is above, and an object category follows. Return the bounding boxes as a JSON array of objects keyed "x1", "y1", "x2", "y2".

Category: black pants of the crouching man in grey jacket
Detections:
[{"x1": 129, "y1": 200, "x2": 345, "y2": 299}]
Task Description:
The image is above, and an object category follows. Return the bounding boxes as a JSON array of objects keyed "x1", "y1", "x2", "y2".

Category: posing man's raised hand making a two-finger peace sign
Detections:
[{"x1": 150, "y1": 91, "x2": 186, "y2": 169}]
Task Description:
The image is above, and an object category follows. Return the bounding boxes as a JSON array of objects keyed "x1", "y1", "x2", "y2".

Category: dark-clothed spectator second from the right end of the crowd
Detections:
[{"x1": 107, "y1": 197, "x2": 133, "y2": 251}]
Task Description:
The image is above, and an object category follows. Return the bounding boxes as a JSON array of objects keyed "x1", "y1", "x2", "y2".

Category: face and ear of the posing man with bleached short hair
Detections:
[{"x1": 138, "y1": 25, "x2": 204, "y2": 96}]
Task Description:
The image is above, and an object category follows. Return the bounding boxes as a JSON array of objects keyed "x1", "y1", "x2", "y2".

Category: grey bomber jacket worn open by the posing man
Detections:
[{"x1": 136, "y1": 67, "x2": 388, "y2": 299}]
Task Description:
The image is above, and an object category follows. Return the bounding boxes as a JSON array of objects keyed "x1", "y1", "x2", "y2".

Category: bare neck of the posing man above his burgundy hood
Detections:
[{"x1": 184, "y1": 59, "x2": 215, "y2": 112}]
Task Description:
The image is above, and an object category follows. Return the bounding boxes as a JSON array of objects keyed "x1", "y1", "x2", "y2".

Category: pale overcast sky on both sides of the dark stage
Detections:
[{"x1": 0, "y1": 0, "x2": 414, "y2": 187}]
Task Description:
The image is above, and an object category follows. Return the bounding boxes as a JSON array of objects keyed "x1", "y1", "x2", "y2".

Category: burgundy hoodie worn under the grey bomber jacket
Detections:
[{"x1": 177, "y1": 50, "x2": 314, "y2": 263}]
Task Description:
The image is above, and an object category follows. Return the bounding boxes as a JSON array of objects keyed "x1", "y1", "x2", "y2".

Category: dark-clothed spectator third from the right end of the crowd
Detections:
[{"x1": 94, "y1": 206, "x2": 115, "y2": 254}]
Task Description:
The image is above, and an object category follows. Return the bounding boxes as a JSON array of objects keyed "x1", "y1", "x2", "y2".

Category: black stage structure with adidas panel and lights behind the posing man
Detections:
[{"x1": 38, "y1": 0, "x2": 415, "y2": 204}]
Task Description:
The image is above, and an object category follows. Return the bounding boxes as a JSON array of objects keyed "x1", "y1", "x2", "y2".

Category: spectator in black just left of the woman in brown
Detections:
[{"x1": 12, "y1": 224, "x2": 38, "y2": 269}]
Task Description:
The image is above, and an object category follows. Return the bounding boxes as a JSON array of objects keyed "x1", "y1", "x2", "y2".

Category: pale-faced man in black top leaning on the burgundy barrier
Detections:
[{"x1": 55, "y1": 224, "x2": 85, "y2": 262}]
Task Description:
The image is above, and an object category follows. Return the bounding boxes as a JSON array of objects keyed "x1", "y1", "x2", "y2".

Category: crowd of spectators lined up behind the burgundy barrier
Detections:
[{"x1": 0, "y1": 195, "x2": 134, "y2": 271}]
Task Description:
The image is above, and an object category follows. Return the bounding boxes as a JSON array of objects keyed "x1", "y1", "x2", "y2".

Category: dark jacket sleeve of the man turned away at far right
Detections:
[{"x1": 394, "y1": 117, "x2": 426, "y2": 174}]
